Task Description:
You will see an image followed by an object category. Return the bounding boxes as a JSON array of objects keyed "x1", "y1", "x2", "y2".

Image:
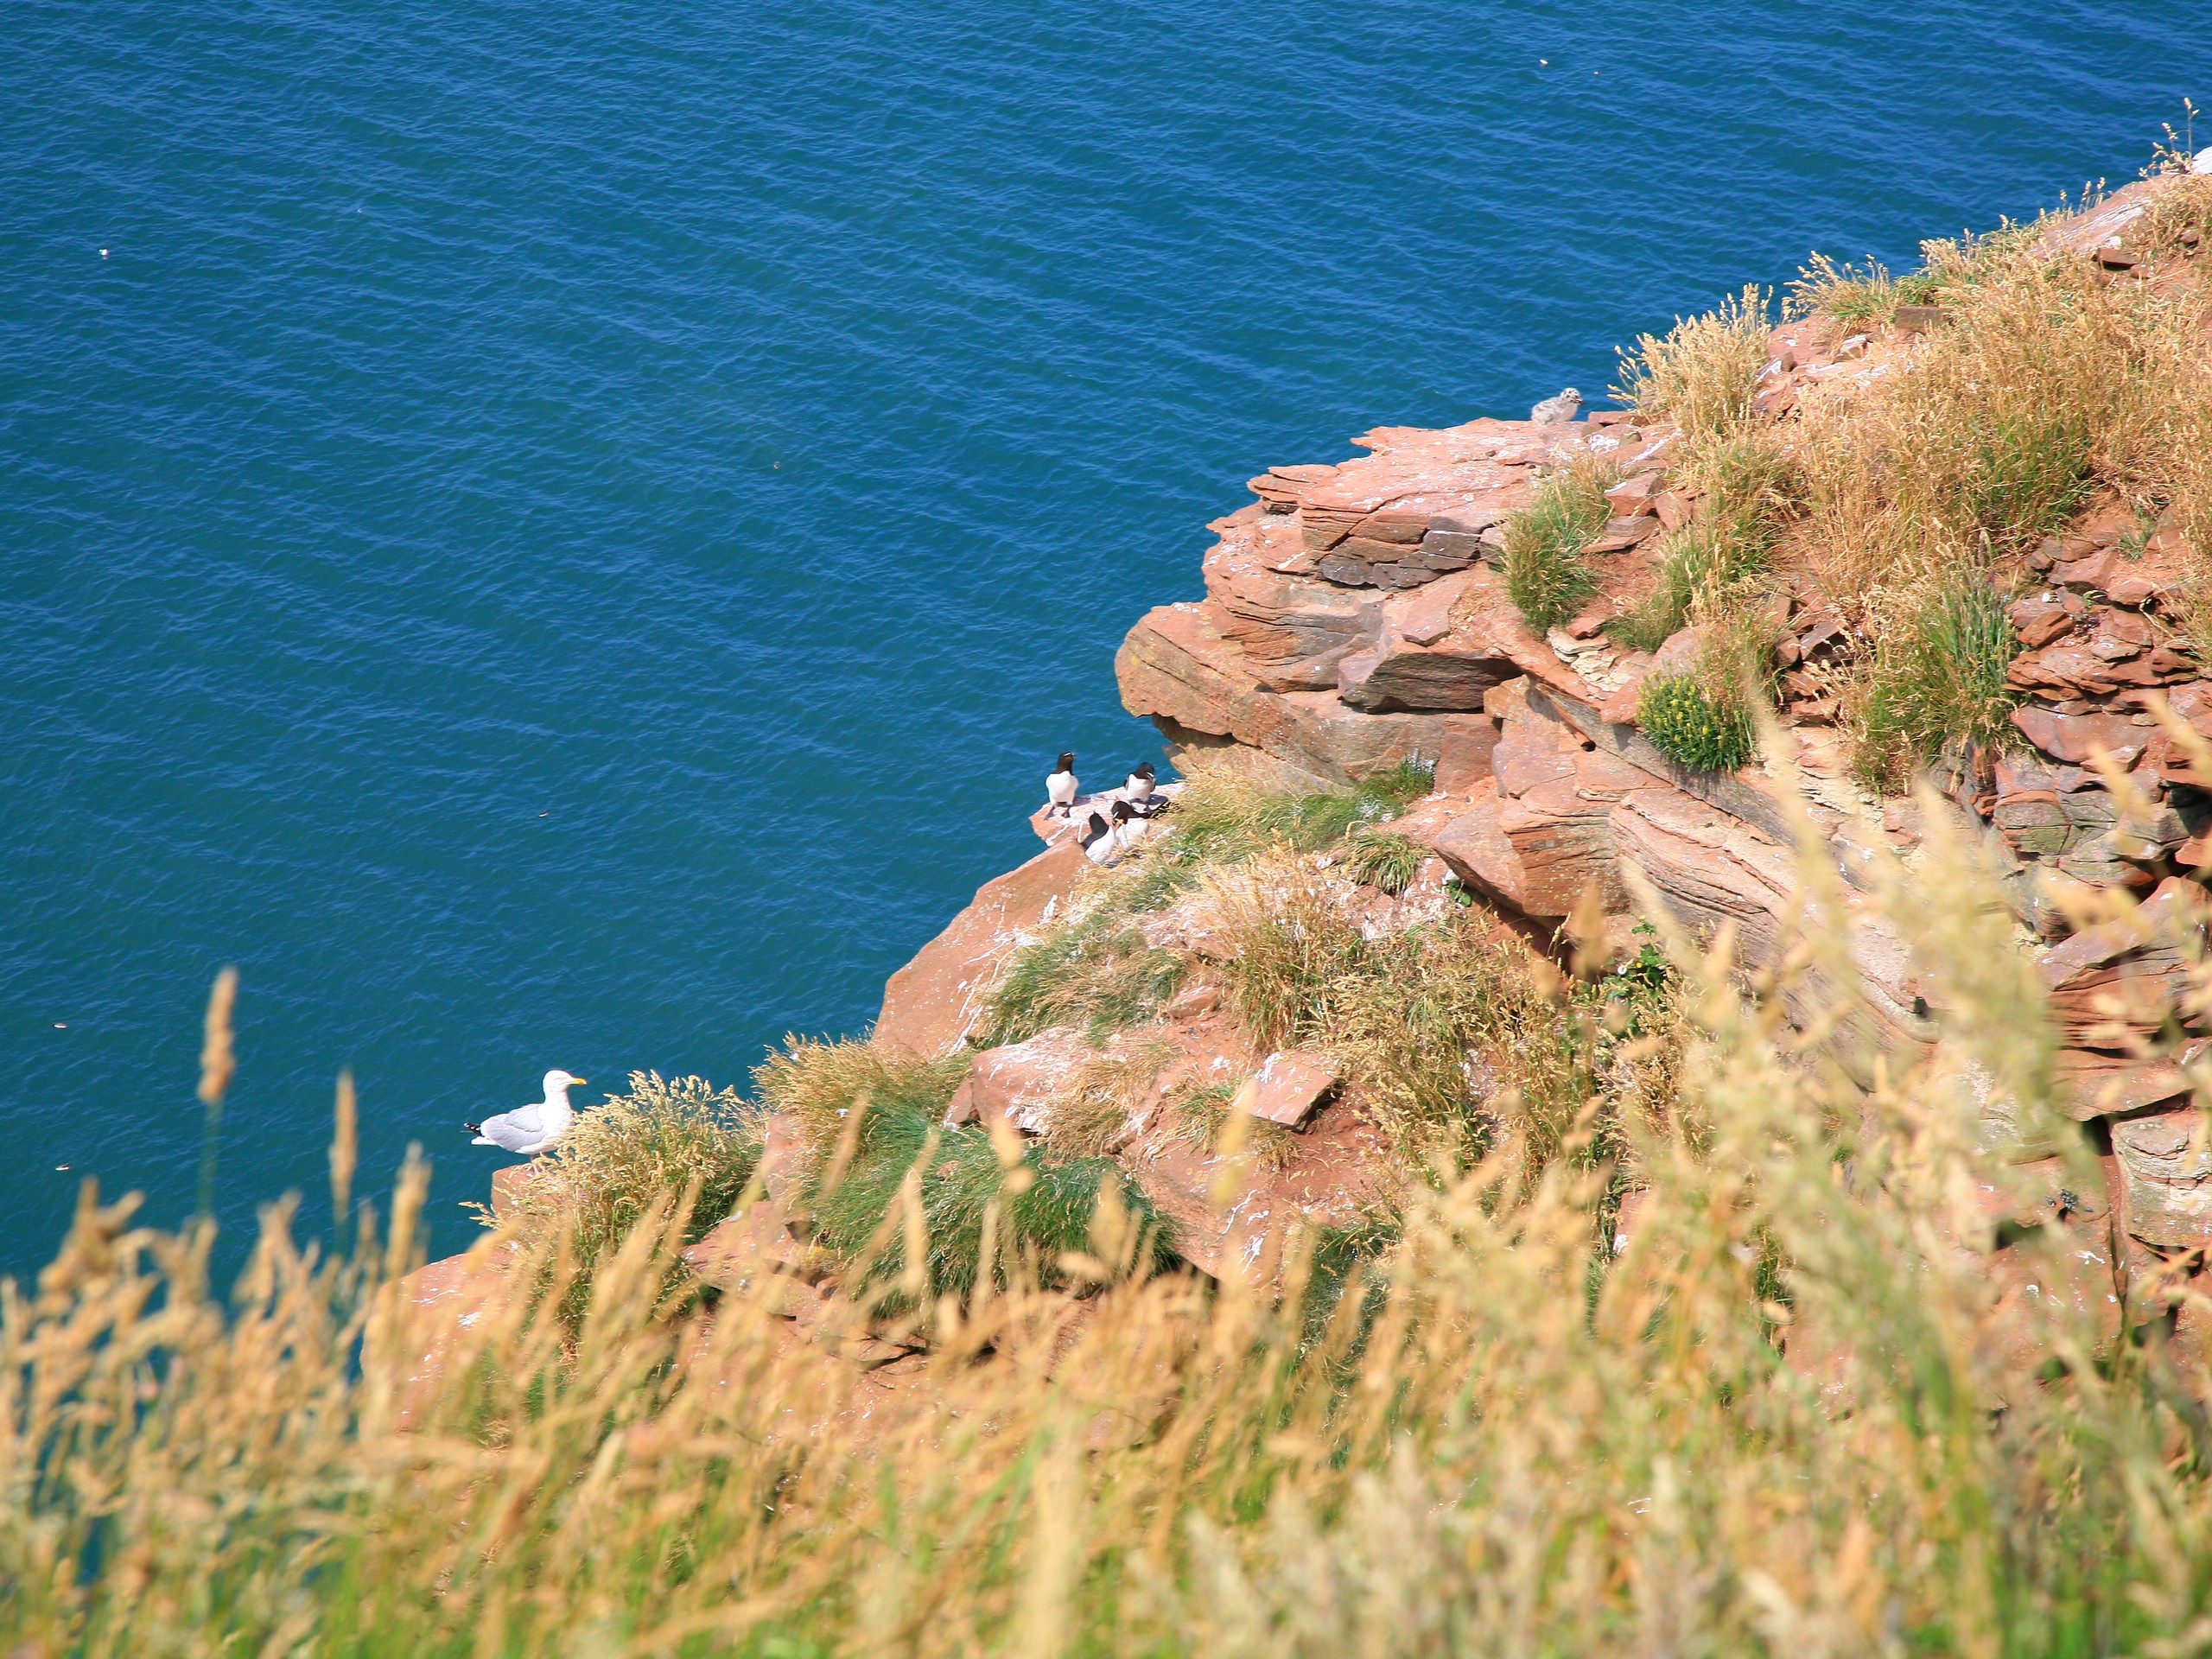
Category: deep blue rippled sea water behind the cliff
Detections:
[{"x1": 0, "y1": 0, "x2": 2212, "y2": 1274}]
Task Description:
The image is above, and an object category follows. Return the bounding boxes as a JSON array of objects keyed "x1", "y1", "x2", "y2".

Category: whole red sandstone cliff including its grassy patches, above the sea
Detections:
[{"x1": 389, "y1": 166, "x2": 2212, "y2": 1360}]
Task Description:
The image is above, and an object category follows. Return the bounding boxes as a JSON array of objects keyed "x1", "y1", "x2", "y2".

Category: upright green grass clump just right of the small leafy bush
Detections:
[{"x1": 1852, "y1": 570, "x2": 2018, "y2": 787}]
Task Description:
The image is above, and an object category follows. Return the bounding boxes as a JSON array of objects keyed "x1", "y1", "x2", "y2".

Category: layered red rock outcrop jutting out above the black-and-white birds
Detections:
[{"x1": 1096, "y1": 181, "x2": 2212, "y2": 1319}]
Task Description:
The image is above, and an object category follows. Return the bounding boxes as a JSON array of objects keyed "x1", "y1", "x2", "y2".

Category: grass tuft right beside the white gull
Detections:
[{"x1": 480, "y1": 1071, "x2": 761, "y2": 1325}]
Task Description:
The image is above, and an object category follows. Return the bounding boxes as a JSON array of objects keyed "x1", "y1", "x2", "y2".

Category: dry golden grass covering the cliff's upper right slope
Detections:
[{"x1": 1781, "y1": 179, "x2": 2212, "y2": 787}]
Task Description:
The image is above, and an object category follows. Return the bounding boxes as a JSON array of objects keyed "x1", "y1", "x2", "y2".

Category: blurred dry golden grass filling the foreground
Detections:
[{"x1": 13, "y1": 836, "x2": 2212, "y2": 1659}]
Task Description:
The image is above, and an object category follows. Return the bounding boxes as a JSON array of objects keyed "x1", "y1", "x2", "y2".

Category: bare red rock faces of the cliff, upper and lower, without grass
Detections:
[{"x1": 818, "y1": 179, "x2": 2212, "y2": 1320}]
